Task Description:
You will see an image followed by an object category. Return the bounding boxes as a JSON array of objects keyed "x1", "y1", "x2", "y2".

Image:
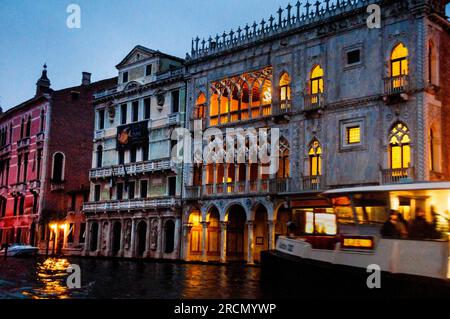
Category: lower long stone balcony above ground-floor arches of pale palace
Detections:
[{"x1": 83, "y1": 197, "x2": 181, "y2": 213}]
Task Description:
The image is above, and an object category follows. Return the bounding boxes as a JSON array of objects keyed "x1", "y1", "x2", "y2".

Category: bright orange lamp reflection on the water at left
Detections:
[{"x1": 23, "y1": 258, "x2": 70, "y2": 299}]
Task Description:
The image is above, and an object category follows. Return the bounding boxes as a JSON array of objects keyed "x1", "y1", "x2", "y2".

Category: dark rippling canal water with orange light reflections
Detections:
[{"x1": 0, "y1": 257, "x2": 274, "y2": 299}]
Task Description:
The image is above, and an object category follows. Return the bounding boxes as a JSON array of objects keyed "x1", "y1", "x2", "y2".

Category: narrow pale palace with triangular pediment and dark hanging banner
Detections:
[{"x1": 84, "y1": 46, "x2": 186, "y2": 259}]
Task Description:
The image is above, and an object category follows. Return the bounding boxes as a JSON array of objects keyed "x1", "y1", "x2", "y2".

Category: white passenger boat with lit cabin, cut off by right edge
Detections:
[{"x1": 262, "y1": 182, "x2": 450, "y2": 294}]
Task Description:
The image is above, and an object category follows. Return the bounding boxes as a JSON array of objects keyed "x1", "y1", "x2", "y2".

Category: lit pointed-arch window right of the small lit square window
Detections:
[{"x1": 389, "y1": 123, "x2": 411, "y2": 169}]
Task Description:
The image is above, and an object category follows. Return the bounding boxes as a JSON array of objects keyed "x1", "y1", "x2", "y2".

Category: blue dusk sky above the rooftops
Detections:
[{"x1": 0, "y1": 0, "x2": 450, "y2": 110}]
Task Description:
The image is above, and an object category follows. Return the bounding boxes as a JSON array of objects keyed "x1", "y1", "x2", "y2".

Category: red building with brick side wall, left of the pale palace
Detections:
[{"x1": 0, "y1": 66, "x2": 117, "y2": 255}]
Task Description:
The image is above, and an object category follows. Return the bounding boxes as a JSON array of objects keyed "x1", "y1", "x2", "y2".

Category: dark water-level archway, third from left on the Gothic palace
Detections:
[{"x1": 227, "y1": 205, "x2": 247, "y2": 260}]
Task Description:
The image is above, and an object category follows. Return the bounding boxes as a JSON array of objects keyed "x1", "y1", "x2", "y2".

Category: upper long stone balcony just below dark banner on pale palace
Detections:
[{"x1": 89, "y1": 159, "x2": 176, "y2": 179}]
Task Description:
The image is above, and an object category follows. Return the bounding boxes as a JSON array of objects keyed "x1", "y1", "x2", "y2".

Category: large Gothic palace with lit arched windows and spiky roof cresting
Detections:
[{"x1": 181, "y1": 0, "x2": 450, "y2": 264}]
